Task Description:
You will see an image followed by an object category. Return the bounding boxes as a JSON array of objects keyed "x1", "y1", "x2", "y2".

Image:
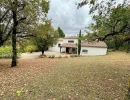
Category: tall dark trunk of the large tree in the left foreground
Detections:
[{"x1": 11, "y1": 0, "x2": 18, "y2": 67}]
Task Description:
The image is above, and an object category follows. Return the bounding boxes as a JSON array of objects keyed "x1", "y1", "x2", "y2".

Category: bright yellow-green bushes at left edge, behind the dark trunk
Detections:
[{"x1": 0, "y1": 46, "x2": 21, "y2": 58}]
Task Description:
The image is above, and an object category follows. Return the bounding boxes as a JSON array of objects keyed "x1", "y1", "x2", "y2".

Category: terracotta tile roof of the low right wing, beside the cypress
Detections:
[{"x1": 81, "y1": 41, "x2": 107, "y2": 48}]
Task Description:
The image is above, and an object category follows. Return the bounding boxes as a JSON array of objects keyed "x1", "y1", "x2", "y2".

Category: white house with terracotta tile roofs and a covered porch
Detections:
[{"x1": 49, "y1": 36, "x2": 107, "y2": 56}]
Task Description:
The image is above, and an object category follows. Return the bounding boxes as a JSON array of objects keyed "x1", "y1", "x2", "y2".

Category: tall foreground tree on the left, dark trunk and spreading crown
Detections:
[{"x1": 0, "y1": 0, "x2": 49, "y2": 67}]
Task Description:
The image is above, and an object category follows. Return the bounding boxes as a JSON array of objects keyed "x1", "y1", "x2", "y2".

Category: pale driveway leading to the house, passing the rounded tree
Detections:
[{"x1": 19, "y1": 51, "x2": 69, "y2": 59}]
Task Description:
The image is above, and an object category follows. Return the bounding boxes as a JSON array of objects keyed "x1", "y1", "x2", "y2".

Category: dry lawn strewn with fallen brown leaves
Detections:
[{"x1": 0, "y1": 52, "x2": 130, "y2": 100}]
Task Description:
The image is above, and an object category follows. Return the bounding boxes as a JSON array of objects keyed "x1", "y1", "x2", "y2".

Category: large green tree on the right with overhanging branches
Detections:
[{"x1": 80, "y1": 0, "x2": 130, "y2": 51}]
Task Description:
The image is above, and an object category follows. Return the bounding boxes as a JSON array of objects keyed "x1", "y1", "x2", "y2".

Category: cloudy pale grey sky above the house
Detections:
[{"x1": 48, "y1": 0, "x2": 122, "y2": 36}]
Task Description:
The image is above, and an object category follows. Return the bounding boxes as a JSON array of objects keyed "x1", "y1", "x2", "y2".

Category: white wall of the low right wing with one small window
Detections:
[{"x1": 80, "y1": 47, "x2": 107, "y2": 56}]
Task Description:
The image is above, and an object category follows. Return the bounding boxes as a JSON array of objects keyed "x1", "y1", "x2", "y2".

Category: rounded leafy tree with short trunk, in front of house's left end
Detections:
[{"x1": 31, "y1": 24, "x2": 58, "y2": 54}]
